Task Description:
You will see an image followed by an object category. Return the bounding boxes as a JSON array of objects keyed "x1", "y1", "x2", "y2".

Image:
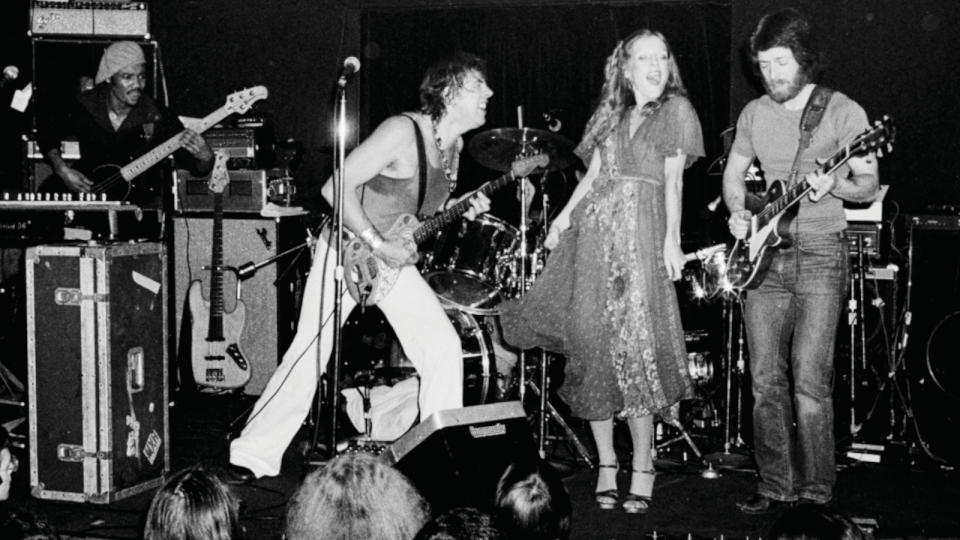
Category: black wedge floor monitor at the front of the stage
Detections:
[{"x1": 385, "y1": 401, "x2": 537, "y2": 512}]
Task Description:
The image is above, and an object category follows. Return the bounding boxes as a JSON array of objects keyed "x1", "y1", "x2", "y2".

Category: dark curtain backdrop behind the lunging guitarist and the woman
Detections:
[{"x1": 360, "y1": 2, "x2": 730, "y2": 242}]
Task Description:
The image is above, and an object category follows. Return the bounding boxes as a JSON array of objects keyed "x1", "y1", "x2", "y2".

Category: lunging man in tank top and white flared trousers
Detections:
[{"x1": 227, "y1": 53, "x2": 493, "y2": 483}]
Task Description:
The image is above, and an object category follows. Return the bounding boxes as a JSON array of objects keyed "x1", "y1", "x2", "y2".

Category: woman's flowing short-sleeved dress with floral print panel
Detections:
[{"x1": 501, "y1": 97, "x2": 704, "y2": 420}]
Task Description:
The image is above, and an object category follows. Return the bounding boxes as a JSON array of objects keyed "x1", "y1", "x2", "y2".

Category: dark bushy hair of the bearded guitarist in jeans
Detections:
[{"x1": 750, "y1": 8, "x2": 826, "y2": 82}]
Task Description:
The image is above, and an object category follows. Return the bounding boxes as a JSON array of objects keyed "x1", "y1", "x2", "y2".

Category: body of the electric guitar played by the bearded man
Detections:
[{"x1": 727, "y1": 180, "x2": 799, "y2": 290}]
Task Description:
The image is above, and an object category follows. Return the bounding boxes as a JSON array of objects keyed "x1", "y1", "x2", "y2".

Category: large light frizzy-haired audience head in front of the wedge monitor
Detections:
[{"x1": 286, "y1": 453, "x2": 430, "y2": 540}]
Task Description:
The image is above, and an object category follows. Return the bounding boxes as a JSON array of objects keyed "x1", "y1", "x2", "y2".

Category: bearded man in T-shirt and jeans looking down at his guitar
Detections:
[{"x1": 723, "y1": 9, "x2": 878, "y2": 514}]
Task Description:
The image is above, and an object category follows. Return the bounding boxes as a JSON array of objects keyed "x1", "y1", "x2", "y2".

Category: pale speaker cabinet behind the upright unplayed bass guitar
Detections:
[{"x1": 173, "y1": 217, "x2": 296, "y2": 395}]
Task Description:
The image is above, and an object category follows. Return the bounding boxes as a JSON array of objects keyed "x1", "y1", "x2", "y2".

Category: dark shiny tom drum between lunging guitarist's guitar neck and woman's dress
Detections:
[{"x1": 423, "y1": 214, "x2": 520, "y2": 315}]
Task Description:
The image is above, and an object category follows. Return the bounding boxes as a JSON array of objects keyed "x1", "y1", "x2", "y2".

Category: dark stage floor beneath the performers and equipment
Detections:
[{"x1": 7, "y1": 395, "x2": 960, "y2": 539}]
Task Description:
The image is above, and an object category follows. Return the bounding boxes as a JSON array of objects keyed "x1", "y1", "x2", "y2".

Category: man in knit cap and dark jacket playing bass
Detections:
[{"x1": 39, "y1": 41, "x2": 213, "y2": 228}]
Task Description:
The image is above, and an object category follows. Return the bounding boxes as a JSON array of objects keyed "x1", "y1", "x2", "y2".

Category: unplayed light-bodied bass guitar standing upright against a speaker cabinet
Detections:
[{"x1": 188, "y1": 150, "x2": 250, "y2": 388}]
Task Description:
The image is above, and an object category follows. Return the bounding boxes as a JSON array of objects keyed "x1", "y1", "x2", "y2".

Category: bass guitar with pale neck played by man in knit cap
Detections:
[{"x1": 90, "y1": 86, "x2": 267, "y2": 201}]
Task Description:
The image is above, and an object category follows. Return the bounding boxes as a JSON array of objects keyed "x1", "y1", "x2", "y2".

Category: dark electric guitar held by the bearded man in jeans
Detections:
[{"x1": 726, "y1": 116, "x2": 895, "y2": 290}]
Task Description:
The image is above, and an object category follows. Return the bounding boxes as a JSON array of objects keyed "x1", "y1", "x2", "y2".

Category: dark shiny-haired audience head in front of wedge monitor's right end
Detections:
[{"x1": 495, "y1": 460, "x2": 571, "y2": 540}]
